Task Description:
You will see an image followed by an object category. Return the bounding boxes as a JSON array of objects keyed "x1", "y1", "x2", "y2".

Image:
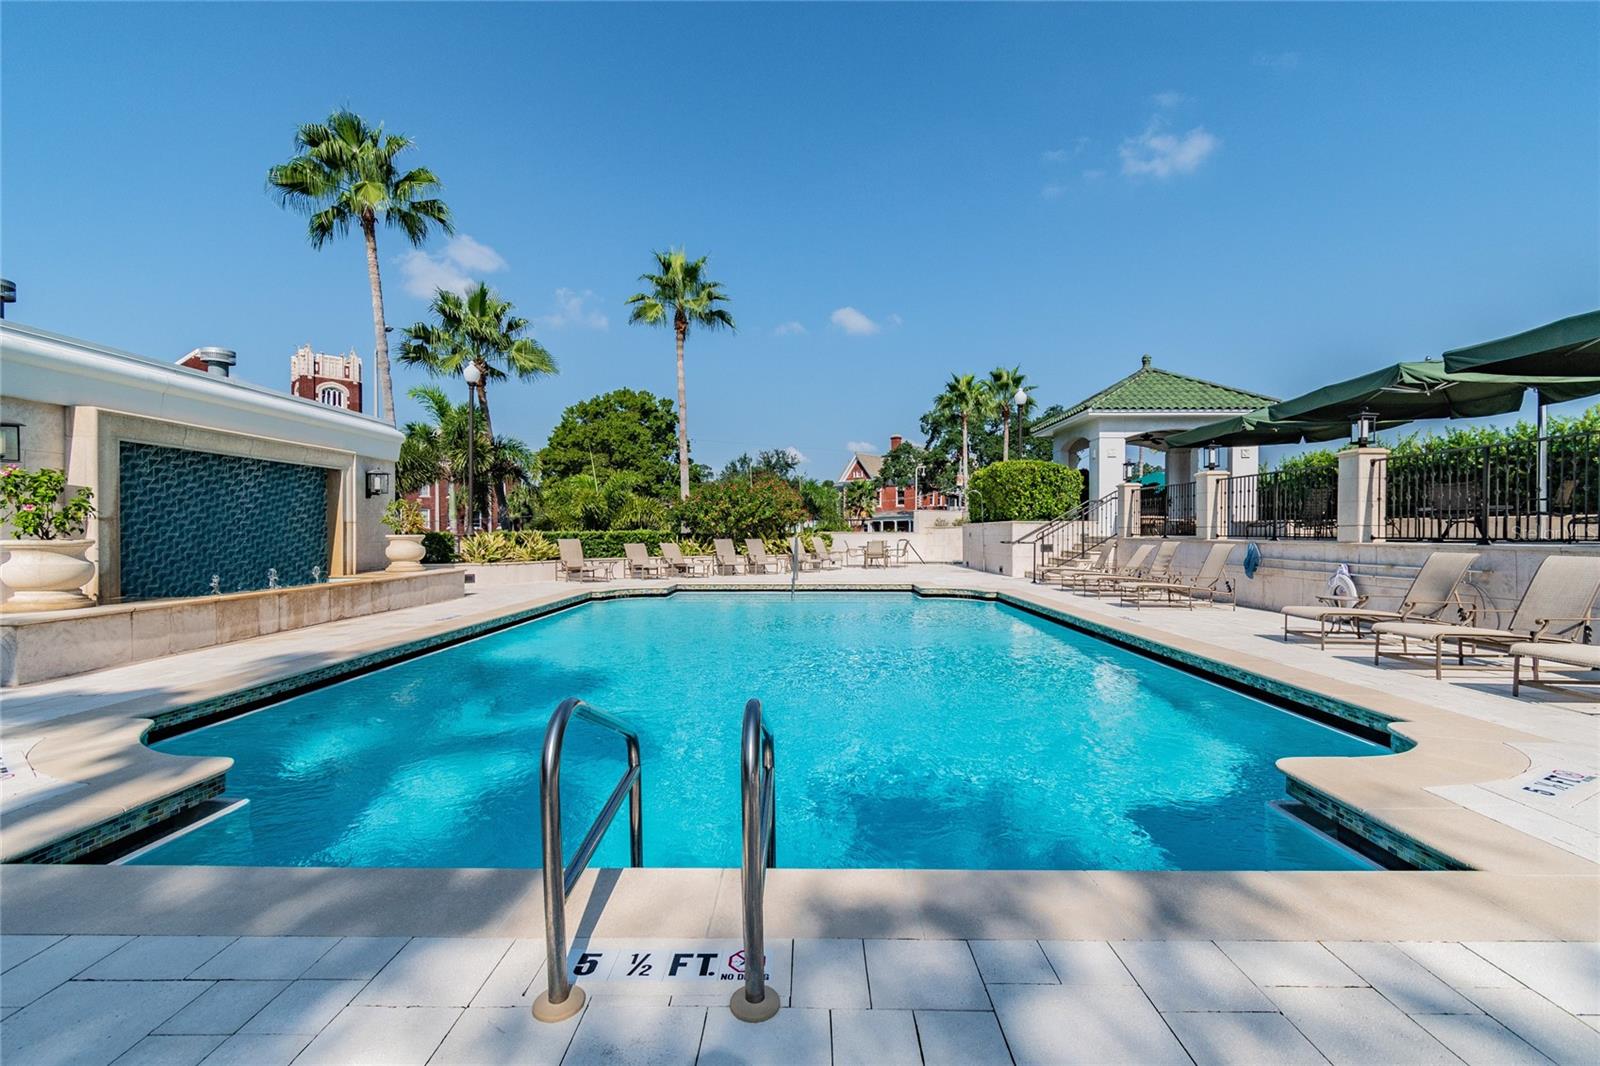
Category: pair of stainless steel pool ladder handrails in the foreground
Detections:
[{"x1": 533, "y1": 688, "x2": 779, "y2": 1021}]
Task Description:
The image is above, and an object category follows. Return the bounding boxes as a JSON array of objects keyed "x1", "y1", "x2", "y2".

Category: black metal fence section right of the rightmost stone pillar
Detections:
[{"x1": 1373, "y1": 432, "x2": 1600, "y2": 544}]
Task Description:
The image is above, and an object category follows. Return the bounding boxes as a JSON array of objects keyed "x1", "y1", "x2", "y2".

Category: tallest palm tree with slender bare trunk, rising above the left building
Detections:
[{"x1": 267, "y1": 110, "x2": 454, "y2": 426}]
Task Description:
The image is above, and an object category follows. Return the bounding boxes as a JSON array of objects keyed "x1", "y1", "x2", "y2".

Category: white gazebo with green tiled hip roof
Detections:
[{"x1": 1030, "y1": 355, "x2": 1275, "y2": 499}]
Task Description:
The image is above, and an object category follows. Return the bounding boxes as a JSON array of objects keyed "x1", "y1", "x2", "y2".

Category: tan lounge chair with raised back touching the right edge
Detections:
[{"x1": 1373, "y1": 555, "x2": 1600, "y2": 679}]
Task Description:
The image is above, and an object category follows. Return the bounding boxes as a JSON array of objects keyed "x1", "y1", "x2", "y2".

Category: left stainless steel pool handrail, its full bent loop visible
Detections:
[{"x1": 533, "y1": 699, "x2": 645, "y2": 1021}]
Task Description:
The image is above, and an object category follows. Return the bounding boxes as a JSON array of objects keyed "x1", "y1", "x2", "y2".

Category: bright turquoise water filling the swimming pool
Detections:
[{"x1": 136, "y1": 592, "x2": 1382, "y2": 869}]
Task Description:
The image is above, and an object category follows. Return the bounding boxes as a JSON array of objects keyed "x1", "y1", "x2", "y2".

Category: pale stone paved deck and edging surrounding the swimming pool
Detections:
[{"x1": 0, "y1": 565, "x2": 1600, "y2": 1063}]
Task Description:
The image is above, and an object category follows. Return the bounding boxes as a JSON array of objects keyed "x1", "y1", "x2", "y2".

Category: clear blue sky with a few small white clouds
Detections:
[{"x1": 0, "y1": 3, "x2": 1600, "y2": 477}]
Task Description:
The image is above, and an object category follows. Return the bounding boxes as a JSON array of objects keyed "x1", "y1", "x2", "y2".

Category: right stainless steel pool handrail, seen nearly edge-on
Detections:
[{"x1": 728, "y1": 699, "x2": 778, "y2": 1021}]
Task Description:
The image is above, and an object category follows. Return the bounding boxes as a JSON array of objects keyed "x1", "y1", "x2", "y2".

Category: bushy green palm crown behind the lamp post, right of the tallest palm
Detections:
[{"x1": 400, "y1": 282, "x2": 557, "y2": 439}]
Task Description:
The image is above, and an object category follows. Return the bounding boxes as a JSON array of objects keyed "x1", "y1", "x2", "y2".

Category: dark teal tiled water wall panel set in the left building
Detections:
[{"x1": 118, "y1": 442, "x2": 330, "y2": 600}]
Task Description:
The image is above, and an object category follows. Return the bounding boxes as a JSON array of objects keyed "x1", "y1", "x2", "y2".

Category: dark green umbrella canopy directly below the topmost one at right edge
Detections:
[{"x1": 1267, "y1": 360, "x2": 1600, "y2": 423}]
